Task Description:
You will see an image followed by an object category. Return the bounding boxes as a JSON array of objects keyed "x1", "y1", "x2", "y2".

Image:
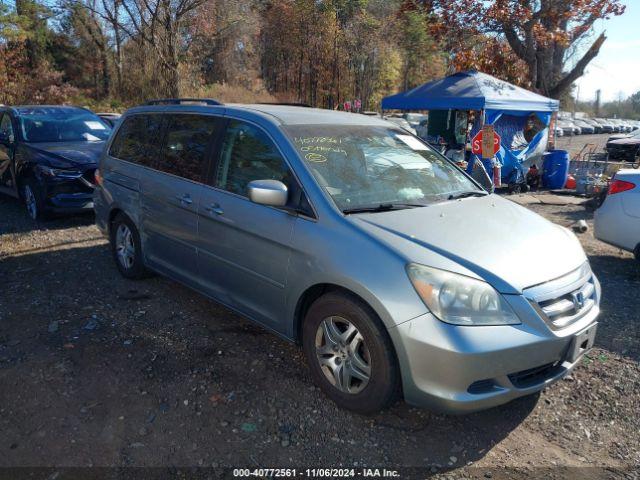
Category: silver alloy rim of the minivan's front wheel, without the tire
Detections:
[{"x1": 315, "y1": 316, "x2": 371, "y2": 394}]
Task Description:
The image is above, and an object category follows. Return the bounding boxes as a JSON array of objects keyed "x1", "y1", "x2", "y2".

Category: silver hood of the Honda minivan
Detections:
[{"x1": 350, "y1": 195, "x2": 586, "y2": 293}]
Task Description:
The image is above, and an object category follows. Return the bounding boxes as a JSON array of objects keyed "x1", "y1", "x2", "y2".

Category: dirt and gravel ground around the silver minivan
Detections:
[{"x1": 0, "y1": 186, "x2": 640, "y2": 478}]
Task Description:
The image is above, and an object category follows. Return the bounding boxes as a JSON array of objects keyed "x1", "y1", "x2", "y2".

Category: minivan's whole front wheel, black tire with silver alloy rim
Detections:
[{"x1": 302, "y1": 292, "x2": 400, "y2": 414}]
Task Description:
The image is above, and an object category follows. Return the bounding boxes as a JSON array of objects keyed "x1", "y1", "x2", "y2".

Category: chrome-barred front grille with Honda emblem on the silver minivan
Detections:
[{"x1": 524, "y1": 263, "x2": 597, "y2": 330}]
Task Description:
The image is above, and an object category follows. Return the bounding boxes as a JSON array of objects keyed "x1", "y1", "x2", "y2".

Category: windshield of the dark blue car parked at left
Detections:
[{"x1": 18, "y1": 107, "x2": 111, "y2": 143}]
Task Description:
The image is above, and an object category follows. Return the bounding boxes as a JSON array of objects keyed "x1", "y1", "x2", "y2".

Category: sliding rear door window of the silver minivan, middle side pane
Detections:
[{"x1": 155, "y1": 114, "x2": 220, "y2": 183}]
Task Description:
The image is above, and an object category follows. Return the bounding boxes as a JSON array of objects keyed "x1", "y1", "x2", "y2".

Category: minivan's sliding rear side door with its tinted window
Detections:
[{"x1": 140, "y1": 114, "x2": 222, "y2": 285}]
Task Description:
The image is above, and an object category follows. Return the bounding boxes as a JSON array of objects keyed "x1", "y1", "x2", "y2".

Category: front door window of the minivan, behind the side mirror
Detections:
[{"x1": 214, "y1": 120, "x2": 290, "y2": 196}]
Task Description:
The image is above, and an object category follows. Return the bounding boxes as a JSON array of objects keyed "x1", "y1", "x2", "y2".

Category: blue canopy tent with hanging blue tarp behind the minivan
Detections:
[{"x1": 382, "y1": 70, "x2": 559, "y2": 183}]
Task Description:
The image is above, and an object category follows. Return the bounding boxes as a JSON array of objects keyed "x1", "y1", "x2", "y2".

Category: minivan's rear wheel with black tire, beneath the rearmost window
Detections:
[{"x1": 109, "y1": 213, "x2": 148, "y2": 280}]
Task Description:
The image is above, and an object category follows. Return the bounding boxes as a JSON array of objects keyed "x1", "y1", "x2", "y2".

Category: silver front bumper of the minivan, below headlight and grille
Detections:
[{"x1": 389, "y1": 277, "x2": 600, "y2": 414}]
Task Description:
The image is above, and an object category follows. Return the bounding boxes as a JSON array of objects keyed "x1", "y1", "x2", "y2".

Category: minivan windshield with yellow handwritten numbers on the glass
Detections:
[{"x1": 285, "y1": 125, "x2": 486, "y2": 211}]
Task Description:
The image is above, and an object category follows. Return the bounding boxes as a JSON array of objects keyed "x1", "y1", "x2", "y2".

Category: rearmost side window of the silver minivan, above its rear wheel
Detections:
[{"x1": 109, "y1": 114, "x2": 162, "y2": 168}]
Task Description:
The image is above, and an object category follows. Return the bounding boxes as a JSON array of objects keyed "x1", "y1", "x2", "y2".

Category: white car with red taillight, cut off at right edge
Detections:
[{"x1": 595, "y1": 169, "x2": 640, "y2": 260}]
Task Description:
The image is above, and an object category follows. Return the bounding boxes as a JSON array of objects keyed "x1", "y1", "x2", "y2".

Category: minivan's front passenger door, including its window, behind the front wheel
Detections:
[{"x1": 198, "y1": 120, "x2": 296, "y2": 331}]
